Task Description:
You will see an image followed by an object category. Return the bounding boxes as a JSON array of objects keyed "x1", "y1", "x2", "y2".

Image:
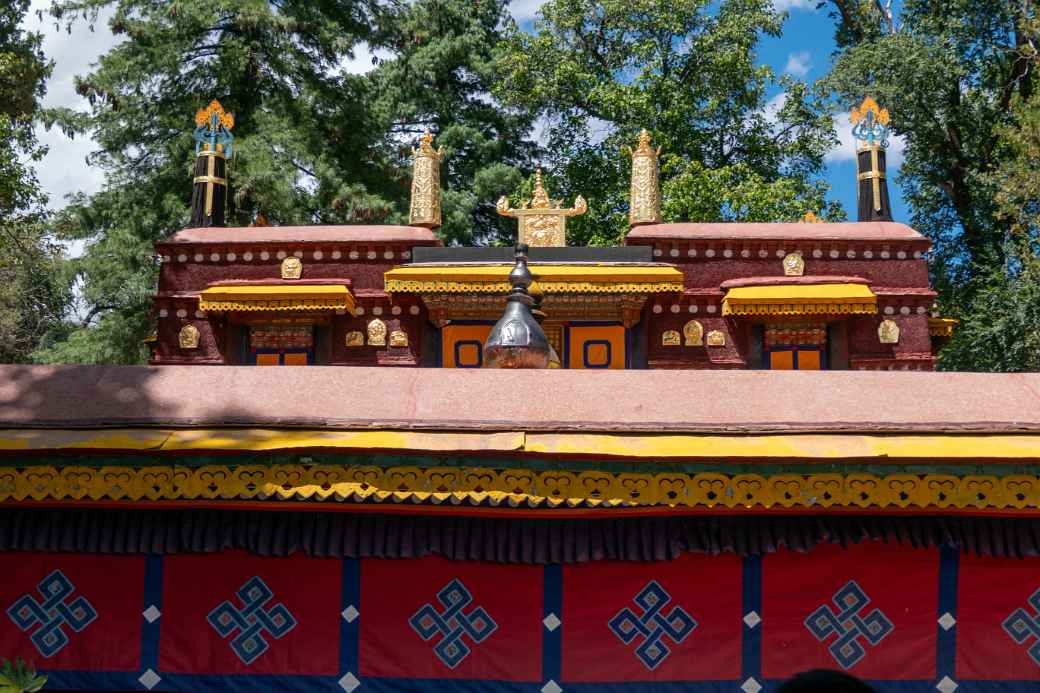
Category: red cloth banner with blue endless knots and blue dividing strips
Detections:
[{"x1": 0, "y1": 542, "x2": 1040, "y2": 693}]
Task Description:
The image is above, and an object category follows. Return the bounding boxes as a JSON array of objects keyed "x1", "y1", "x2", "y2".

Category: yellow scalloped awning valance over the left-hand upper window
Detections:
[{"x1": 199, "y1": 284, "x2": 355, "y2": 315}]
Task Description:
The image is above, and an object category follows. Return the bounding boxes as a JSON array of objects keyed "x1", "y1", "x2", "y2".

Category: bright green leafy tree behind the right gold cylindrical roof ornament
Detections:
[{"x1": 496, "y1": 0, "x2": 842, "y2": 245}]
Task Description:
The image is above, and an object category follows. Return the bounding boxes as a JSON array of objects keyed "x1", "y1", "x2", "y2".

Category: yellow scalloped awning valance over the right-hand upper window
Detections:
[{"x1": 722, "y1": 284, "x2": 878, "y2": 315}]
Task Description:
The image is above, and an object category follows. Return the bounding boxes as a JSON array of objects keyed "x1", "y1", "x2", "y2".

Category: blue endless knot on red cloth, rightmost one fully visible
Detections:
[{"x1": 805, "y1": 580, "x2": 895, "y2": 669}]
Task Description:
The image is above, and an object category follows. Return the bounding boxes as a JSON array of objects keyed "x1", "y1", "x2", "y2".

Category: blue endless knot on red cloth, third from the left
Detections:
[{"x1": 408, "y1": 580, "x2": 498, "y2": 669}]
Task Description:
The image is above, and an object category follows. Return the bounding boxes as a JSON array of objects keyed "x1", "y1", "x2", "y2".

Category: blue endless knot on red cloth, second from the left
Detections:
[{"x1": 206, "y1": 576, "x2": 296, "y2": 665}]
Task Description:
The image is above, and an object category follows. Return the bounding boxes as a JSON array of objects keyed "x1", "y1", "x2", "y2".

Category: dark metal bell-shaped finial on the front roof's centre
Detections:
[{"x1": 484, "y1": 243, "x2": 549, "y2": 368}]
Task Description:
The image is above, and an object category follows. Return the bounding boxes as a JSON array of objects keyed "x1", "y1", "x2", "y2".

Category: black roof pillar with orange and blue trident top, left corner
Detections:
[{"x1": 191, "y1": 99, "x2": 235, "y2": 227}]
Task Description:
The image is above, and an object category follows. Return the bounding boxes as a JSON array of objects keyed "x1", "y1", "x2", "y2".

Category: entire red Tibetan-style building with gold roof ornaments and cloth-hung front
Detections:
[{"x1": 0, "y1": 99, "x2": 1040, "y2": 693}]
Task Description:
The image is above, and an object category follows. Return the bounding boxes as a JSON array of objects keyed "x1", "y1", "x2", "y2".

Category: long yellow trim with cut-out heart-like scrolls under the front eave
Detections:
[{"x1": 0, "y1": 464, "x2": 1040, "y2": 511}]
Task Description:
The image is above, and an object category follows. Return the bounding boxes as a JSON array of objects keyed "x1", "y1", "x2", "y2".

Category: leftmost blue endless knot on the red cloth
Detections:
[{"x1": 7, "y1": 570, "x2": 98, "y2": 658}]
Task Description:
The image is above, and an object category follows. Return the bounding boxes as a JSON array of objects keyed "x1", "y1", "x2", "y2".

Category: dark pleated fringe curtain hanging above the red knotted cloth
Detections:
[{"x1": 0, "y1": 508, "x2": 1040, "y2": 564}]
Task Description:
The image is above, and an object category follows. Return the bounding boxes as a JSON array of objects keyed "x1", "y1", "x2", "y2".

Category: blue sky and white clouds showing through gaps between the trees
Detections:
[{"x1": 27, "y1": 0, "x2": 909, "y2": 228}]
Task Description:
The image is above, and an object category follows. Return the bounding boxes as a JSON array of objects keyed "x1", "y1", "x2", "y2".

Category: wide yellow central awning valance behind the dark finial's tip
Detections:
[{"x1": 384, "y1": 264, "x2": 682, "y2": 293}]
